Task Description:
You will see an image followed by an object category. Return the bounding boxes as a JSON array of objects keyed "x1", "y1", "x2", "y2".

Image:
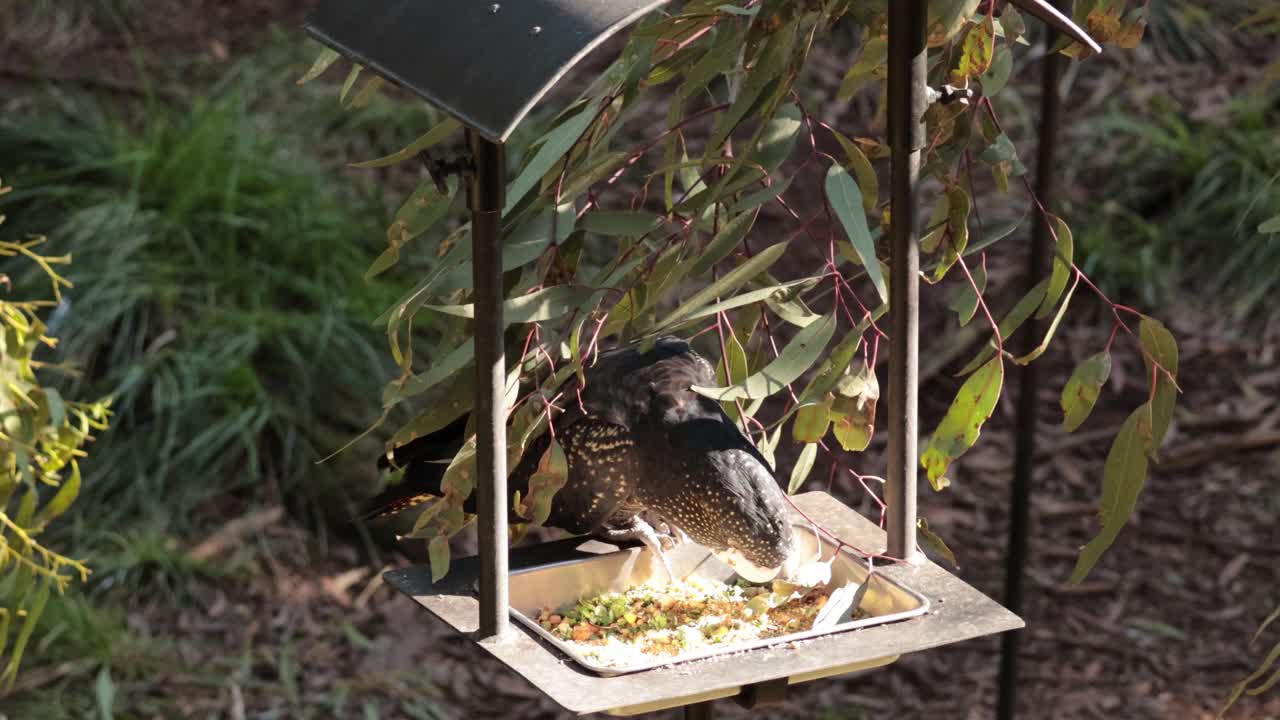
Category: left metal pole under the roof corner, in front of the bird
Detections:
[{"x1": 467, "y1": 129, "x2": 509, "y2": 639}]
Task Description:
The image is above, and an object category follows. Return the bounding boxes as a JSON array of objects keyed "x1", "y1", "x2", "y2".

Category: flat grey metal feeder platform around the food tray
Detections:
[{"x1": 385, "y1": 492, "x2": 1023, "y2": 716}]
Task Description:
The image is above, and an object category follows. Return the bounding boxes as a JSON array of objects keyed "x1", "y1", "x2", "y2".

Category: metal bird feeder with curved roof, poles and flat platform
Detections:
[{"x1": 305, "y1": 0, "x2": 1097, "y2": 717}]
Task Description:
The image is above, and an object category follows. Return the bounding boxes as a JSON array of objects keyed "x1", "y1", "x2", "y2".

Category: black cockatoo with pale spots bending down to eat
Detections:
[{"x1": 367, "y1": 337, "x2": 801, "y2": 582}]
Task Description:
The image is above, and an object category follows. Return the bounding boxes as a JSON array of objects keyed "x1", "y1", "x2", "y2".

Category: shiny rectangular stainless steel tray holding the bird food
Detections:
[{"x1": 499, "y1": 525, "x2": 929, "y2": 676}]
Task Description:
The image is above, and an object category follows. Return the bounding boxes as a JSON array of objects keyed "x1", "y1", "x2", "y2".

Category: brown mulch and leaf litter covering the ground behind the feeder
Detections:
[{"x1": 0, "y1": 0, "x2": 1280, "y2": 720}]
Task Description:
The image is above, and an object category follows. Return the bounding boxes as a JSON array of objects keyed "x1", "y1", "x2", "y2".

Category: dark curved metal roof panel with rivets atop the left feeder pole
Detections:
[{"x1": 303, "y1": 0, "x2": 669, "y2": 142}]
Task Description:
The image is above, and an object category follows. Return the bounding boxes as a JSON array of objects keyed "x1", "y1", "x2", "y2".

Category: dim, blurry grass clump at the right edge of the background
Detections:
[{"x1": 1076, "y1": 92, "x2": 1280, "y2": 318}]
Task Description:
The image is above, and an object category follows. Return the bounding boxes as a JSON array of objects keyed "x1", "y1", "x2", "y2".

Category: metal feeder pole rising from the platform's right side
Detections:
[{"x1": 884, "y1": 0, "x2": 928, "y2": 560}]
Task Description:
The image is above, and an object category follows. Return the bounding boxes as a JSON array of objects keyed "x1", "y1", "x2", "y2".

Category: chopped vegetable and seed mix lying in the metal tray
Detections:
[{"x1": 538, "y1": 578, "x2": 864, "y2": 669}]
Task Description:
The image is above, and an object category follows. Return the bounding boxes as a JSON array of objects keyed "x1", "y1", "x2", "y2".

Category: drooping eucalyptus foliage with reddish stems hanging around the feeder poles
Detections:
[{"x1": 303, "y1": 0, "x2": 1178, "y2": 579}]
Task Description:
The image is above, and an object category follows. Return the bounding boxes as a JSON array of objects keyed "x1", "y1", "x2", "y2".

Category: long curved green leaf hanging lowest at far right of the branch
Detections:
[{"x1": 1070, "y1": 402, "x2": 1151, "y2": 584}]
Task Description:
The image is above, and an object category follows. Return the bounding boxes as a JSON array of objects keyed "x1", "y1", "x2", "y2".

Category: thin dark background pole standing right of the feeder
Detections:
[{"x1": 996, "y1": 16, "x2": 1064, "y2": 720}]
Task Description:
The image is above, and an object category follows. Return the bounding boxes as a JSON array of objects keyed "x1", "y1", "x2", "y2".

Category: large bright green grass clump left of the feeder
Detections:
[{"x1": 0, "y1": 83, "x2": 399, "y2": 556}]
